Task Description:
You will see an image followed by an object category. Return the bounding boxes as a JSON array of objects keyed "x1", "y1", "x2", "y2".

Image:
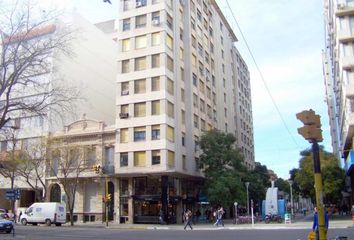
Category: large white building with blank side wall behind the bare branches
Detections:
[{"x1": 0, "y1": 13, "x2": 117, "y2": 208}]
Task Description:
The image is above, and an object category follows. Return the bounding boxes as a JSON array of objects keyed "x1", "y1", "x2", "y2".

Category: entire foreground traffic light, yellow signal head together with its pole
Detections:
[{"x1": 296, "y1": 109, "x2": 327, "y2": 240}]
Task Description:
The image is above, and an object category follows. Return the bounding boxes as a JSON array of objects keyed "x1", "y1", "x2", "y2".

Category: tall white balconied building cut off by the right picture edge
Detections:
[{"x1": 323, "y1": 0, "x2": 354, "y2": 206}]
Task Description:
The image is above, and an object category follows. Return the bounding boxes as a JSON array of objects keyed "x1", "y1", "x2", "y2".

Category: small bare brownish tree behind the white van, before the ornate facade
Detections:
[{"x1": 48, "y1": 139, "x2": 87, "y2": 226}]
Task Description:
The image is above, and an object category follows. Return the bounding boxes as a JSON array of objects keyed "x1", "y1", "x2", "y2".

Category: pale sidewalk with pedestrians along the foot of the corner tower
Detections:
[{"x1": 63, "y1": 216, "x2": 354, "y2": 230}]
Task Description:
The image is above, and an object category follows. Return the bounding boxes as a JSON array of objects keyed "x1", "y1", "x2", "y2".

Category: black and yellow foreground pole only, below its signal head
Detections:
[{"x1": 312, "y1": 141, "x2": 327, "y2": 240}]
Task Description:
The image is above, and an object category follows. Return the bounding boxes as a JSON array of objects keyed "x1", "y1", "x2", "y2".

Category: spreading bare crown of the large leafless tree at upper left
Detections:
[{"x1": 0, "y1": 0, "x2": 80, "y2": 129}]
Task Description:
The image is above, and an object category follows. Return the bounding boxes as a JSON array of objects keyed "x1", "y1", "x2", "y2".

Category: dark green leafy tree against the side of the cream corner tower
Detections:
[{"x1": 200, "y1": 130, "x2": 247, "y2": 206}]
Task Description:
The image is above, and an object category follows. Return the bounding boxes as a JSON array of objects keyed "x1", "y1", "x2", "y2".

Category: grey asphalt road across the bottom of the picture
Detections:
[{"x1": 0, "y1": 226, "x2": 354, "y2": 240}]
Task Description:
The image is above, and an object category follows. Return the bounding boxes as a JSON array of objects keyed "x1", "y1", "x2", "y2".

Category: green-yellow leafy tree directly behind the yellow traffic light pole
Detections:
[{"x1": 295, "y1": 146, "x2": 345, "y2": 203}]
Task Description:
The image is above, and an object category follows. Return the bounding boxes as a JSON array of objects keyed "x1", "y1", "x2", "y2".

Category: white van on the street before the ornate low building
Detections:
[{"x1": 20, "y1": 202, "x2": 66, "y2": 226}]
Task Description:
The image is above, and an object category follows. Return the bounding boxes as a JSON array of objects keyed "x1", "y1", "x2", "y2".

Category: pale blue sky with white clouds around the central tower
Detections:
[{"x1": 42, "y1": 0, "x2": 332, "y2": 179}]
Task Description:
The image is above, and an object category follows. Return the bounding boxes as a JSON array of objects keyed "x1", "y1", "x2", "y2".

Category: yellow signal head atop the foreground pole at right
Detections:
[{"x1": 296, "y1": 109, "x2": 323, "y2": 142}]
